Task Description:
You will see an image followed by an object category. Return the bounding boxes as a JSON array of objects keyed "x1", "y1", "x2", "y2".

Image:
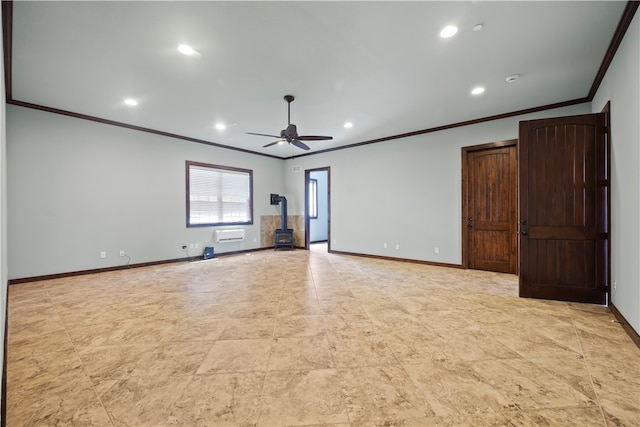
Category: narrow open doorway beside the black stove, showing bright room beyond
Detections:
[{"x1": 305, "y1": 167, "x2": 331, "y2": 251}]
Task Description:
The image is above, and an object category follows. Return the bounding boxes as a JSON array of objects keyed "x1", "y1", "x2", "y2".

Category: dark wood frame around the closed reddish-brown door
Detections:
[{"x1": 461, "y1": 139, "x2": 520, "y2": 274}]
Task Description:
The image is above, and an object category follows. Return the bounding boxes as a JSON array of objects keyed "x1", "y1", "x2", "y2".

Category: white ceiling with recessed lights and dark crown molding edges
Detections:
[{"x1": 11, "y1": 1, "x2": 626, "y2": 158}]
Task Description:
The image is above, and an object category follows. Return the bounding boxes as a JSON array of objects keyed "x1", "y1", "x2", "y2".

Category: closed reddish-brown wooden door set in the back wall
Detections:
[{"x1": 463, "y1": 140, "x2": 518, "y2": 273}]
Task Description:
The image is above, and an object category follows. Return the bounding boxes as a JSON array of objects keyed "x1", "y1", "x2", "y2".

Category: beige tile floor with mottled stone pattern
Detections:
[{"x1": 7, "y1": 248, "x2": 640, "y2": 426}]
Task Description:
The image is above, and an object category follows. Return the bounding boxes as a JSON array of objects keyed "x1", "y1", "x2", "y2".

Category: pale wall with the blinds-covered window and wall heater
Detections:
[{"x1": 7, "y1": 105, "x2": 283, "y2": 279}]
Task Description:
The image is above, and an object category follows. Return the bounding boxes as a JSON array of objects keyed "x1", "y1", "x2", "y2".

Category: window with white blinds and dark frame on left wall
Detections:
[{"x1": 187, "y1": 161, "x2": 253, "y2": 227}]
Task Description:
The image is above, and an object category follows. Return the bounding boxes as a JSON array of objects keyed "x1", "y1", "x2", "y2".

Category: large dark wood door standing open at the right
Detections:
[{"x1": 518, "y1": 114, "x2": 609, "y2": 304}]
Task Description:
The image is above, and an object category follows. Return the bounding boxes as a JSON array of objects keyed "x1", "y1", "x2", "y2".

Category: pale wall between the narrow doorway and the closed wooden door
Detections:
[{"x1": 285, "y1": 104, "x2": 591, "y2": 264}]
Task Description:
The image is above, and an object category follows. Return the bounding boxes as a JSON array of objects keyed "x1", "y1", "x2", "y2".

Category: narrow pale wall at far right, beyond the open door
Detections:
[{"x1": 592, "y1": 13, "x2": 640, "y2": 333}]
